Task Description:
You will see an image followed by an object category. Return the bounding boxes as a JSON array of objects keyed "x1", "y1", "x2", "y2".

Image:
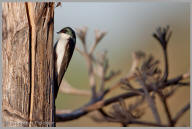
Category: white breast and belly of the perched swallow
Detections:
[{"x1": 56, "y1": 38, "x2": 68, "y2": 74}]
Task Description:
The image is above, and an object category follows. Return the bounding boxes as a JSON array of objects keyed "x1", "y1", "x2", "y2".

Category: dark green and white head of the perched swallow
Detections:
[{"x1": 57, "y1": 27, "x2": 76, "y2": 42}]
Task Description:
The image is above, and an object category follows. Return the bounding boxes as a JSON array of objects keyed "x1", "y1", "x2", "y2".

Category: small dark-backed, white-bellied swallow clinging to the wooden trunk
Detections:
[{"x1": 53, "y1": 27, "x2": 76, "y2": 99}]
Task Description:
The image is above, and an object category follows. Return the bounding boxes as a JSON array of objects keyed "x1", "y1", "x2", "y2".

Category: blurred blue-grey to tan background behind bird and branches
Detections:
[{"x1": 54, "y1": 2, "x2": 190, "y2": 126}]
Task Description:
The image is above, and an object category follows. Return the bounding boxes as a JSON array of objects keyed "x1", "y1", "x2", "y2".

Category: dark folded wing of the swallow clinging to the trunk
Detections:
[{"x1": 57, "y1": 38, "x2": 75, "y2": 86}]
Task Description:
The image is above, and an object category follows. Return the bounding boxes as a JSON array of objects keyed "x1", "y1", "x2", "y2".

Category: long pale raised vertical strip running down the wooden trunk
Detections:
[{"x1": 25, "y1": 2, "x2": 36, "y2": 126}]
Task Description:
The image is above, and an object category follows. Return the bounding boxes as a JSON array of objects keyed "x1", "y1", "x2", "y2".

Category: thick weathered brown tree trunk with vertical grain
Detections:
[{"x1": 2, "y1": 2, "x2": 55, "y2": 126}]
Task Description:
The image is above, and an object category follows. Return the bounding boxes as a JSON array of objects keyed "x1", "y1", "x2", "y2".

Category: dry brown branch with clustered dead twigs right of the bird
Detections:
[{"x1": 56, "y1": 26, "x2": 190, "y2": 126}]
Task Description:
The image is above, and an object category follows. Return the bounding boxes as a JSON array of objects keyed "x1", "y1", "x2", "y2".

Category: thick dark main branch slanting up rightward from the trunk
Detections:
[{"x1": 56, "y1": 73, "x2": 189, "y2": 122}]
